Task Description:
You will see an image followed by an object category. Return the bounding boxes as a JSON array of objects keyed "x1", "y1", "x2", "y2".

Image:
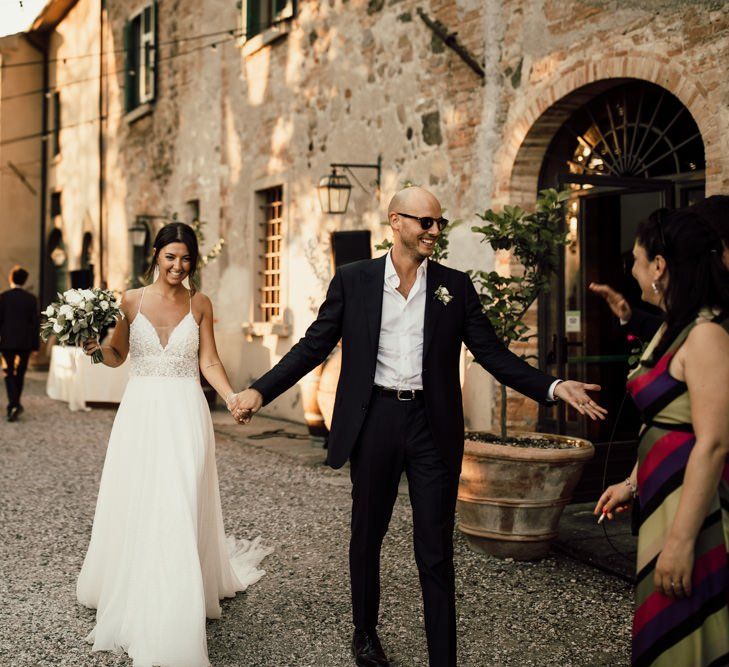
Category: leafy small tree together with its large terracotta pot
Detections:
[{"x1": 458, "y1": 189, "x2": 594, "y2": 560}]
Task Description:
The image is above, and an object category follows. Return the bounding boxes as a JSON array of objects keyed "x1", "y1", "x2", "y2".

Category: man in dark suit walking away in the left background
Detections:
[{"x1": 0, "y1": 266, "x2": 40, "y2": 422}]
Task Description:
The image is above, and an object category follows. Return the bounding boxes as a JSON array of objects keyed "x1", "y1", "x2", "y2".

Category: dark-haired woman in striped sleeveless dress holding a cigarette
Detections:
[{"x1": 595, "y1": 211, "x2": 729, "y2": 667}]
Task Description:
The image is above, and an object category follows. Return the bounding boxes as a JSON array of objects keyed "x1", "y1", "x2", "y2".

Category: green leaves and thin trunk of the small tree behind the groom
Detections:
[{"x1": 469, "y1": 188, "x2": 571, "y2": 440}]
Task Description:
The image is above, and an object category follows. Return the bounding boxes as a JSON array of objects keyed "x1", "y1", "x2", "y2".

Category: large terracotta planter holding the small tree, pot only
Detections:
[{"x1": 458, "y1": 433, "x2": 595, "y2": 560}]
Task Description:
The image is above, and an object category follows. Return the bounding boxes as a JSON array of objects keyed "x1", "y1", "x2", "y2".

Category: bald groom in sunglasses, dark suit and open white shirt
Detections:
[{"x1": 232, "y1": 187, "x2": 605, "y2": 667}]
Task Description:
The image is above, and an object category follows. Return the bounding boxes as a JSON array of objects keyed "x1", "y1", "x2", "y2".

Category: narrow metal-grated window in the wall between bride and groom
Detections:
[{"x1": 259, "y1": 186, "x2": 283, "y2": 322}]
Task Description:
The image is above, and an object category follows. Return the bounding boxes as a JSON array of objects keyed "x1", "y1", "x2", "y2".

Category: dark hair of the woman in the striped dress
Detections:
[{"x1": 636, "y1": 209, "x2": 729, "y2": 366}]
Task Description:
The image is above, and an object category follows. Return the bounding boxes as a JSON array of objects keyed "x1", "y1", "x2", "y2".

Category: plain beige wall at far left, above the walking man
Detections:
[{"x1": 0, "y1": 34, "x2": 43, "y2": 294}]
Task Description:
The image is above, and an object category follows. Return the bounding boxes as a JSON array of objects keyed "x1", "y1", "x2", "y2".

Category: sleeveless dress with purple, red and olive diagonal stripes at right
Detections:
[{"x1": 628, "y1": 320, "x2": 729, "y2": 667}]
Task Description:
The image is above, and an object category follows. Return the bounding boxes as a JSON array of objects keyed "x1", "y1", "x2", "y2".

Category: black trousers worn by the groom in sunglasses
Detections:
[{"x1": 349, "y1": 394, "x2": 458, "y2": 667}]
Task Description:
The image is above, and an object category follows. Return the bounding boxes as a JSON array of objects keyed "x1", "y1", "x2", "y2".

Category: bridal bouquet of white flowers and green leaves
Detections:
[{"x1": 41, "y1": 287, "x2": 121, "y2": 364}]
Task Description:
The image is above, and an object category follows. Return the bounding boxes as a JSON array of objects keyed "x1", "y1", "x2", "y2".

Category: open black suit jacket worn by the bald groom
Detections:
[{"x1": 252, "y1": 257, "x2": 555, "y2": 472}]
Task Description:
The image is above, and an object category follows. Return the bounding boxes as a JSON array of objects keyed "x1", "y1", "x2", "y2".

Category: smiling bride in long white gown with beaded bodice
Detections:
[{"x1": 76, "y1": 222, "x2": 271, "y2": 667}]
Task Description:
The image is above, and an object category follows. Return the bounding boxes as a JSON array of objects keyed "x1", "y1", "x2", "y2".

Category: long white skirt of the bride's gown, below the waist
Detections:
[{"x1": 76, "y1": 376, "x2": 271, "y2": 667}]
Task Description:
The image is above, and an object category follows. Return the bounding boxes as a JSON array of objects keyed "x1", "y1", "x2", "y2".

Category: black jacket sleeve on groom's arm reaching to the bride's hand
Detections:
[{"x1": 251, "y1": 271, "x2": 344, "y2": 405}]
